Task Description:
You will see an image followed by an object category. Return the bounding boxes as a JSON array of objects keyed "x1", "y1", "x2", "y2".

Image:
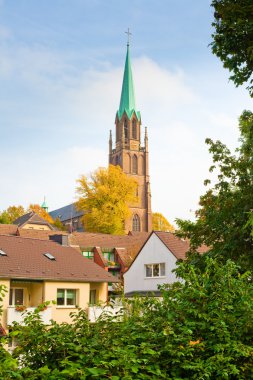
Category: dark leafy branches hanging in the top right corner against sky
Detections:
[{"x1": 211, "y1": 0, "x2": 253, "y2": 96}]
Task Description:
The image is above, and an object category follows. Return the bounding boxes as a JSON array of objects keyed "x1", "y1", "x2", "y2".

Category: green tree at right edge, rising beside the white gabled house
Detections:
[{"x1": 177, "y1": 111, "x2": 253, "y2": 270}]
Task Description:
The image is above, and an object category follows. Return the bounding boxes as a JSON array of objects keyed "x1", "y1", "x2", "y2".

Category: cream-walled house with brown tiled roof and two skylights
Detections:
[{"x1": 0, "y1": 235, "x2": 117, "y2": 329}]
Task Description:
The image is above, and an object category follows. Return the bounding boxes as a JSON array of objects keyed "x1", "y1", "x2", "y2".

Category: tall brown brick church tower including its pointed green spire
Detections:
[{"x1": 109, "y1": 42, "x2": 152, "y2": 232}]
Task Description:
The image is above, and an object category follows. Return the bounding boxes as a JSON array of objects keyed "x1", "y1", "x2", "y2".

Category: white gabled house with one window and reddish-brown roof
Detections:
[{"x1": 124, "y1": 231, "x2": 207, "y2": 297}]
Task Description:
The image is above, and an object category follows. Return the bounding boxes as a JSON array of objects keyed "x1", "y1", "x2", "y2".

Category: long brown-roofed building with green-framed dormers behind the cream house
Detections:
[{"x1": 0, "y1": 224, "x2": 150, "y2": 295}]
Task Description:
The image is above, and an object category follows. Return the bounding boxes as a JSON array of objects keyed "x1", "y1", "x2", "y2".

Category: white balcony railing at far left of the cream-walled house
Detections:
[{"x1": 7, "y1": 306, "x2": 52, "y2": 325}]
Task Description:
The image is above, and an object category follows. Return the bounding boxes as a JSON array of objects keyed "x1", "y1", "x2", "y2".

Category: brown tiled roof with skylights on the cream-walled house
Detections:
[{"x1": 0, "y1": 235, "x2": 117, "y2": 282}]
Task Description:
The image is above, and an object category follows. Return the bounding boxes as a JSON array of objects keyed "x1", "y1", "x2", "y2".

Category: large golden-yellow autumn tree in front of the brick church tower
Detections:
[{"x1": 76, "y1": 165, "x2": 137, "y2": 234}]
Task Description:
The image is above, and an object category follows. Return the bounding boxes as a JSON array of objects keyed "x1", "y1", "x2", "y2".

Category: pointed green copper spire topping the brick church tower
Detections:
[{"x1": 117, "y1": 44, "x2": 141, "y2": 120}]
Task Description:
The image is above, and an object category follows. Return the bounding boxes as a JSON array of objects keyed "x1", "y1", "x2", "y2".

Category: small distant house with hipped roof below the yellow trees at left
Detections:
[{"x1": 13, "y1": 211, "x2": 55, "y2": 231}]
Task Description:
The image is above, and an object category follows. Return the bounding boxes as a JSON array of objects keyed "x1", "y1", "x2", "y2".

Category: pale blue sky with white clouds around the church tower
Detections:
[{"x1": 0, "y1": 0, "x2": 252, "y2": 223}]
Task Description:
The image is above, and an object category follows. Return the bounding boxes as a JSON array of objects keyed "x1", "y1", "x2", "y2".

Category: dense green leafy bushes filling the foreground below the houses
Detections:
[{"x1": 0, "y1": 256, "x2": 253, "y2": 380}]
